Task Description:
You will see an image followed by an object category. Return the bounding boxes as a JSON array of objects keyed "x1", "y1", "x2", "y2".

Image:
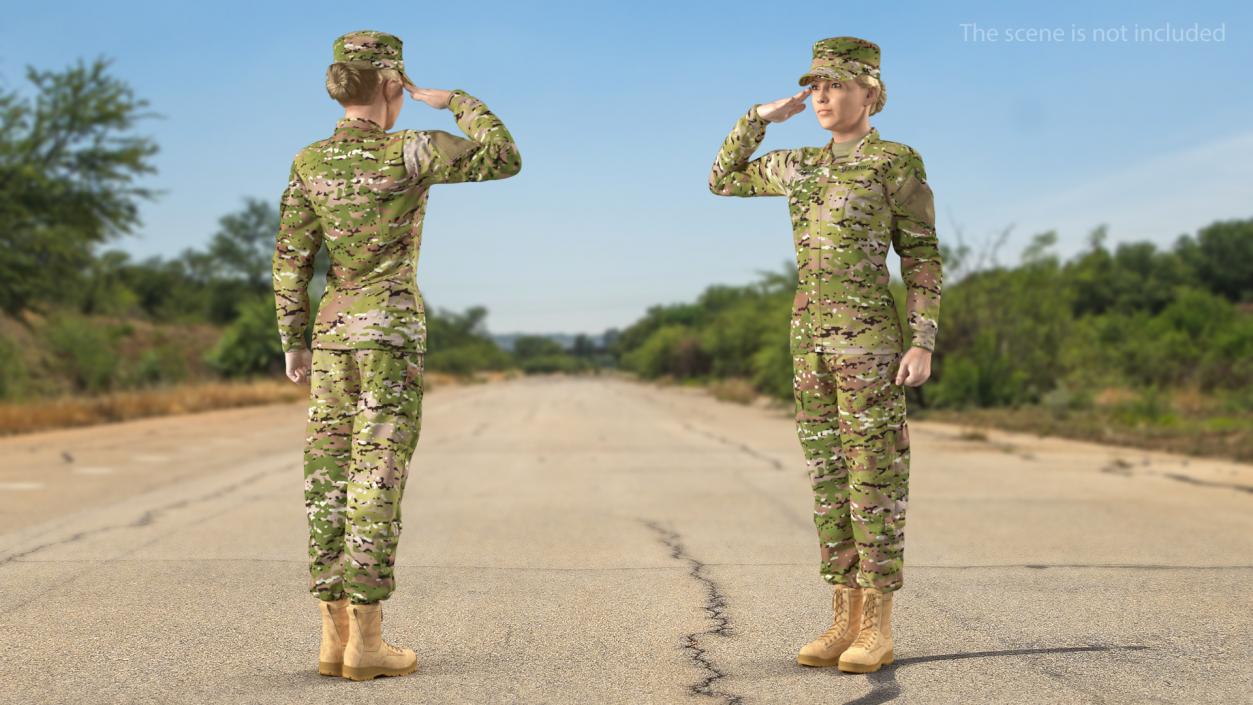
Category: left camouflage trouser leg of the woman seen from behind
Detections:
[{"x1": 304, "y1": 348, "x2": 358, "y2": 600}]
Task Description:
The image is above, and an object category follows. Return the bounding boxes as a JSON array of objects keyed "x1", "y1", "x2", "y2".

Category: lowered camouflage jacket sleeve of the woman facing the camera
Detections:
[{"x1": 886, "y1": 149, "x2": 942, "y2": 351}]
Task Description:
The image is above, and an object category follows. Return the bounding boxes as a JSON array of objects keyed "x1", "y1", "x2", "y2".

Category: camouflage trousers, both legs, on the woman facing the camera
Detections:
[{"x1": 792, "y1": 351, "x2": 910, "y2": 591}]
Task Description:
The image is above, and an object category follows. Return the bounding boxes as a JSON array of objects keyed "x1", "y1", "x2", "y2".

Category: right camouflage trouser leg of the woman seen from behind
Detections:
[{"x1": 345, "y1": 349, "x2": 424, "y2": 604}]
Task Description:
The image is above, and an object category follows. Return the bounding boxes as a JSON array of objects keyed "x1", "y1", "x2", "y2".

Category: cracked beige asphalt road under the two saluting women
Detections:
[{"x1": 0, "y1": 377, "x2": 1253, "y2": 705}]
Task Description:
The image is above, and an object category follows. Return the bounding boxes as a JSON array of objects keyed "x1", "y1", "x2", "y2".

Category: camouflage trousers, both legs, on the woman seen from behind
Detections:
[{"x1": 304, "y1": 348, "x2": 424, "y2": 604}]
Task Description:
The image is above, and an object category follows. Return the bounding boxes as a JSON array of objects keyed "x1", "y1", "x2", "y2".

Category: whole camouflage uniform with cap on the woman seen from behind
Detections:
[{"x1": 273, "y1": 31, "x2": 521, "y2": 602}]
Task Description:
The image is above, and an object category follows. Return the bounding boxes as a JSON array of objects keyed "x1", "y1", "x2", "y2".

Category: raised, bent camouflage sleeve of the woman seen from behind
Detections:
[{"x1": 405, "y1": 88, "x2": 523, "y2": 185}]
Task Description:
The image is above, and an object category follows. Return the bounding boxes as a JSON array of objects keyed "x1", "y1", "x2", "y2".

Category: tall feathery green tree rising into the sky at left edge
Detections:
[{"x1": 0, "y1": 58, "x2": 158, "y2": 314}]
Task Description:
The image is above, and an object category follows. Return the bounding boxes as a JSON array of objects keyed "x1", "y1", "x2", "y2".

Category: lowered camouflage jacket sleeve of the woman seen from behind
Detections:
[{"x1": 273, "y1": 163, "x2": 322, "y2": 352}]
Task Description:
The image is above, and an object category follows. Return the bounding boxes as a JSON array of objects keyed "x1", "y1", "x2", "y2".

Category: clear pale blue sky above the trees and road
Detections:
[{"x1": 0, "y1": 0, "x2": 1253, "y2": 333}]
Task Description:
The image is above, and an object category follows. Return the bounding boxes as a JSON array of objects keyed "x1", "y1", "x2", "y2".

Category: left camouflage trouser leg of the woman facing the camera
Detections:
[{"x1": 792, "y1": 352, "x2": 857, "y2": 585}]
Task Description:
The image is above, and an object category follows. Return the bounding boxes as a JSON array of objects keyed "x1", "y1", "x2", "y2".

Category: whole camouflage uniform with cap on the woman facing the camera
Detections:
[{"x1": 709, "y1": 38, "x2": 941, "y2": 591}]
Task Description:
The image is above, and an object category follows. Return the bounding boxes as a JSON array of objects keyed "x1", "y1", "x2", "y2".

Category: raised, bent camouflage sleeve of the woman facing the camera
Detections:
[{"x1": 709, "y1": 104, "x2": 796, "y2": 197}]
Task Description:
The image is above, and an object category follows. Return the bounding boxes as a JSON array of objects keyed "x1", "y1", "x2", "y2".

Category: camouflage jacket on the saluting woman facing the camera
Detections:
[{"x1": 709, "y1": 105, "x2": 941, "y2": 353}]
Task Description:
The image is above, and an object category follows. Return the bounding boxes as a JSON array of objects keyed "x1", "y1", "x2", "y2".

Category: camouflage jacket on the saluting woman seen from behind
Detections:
[{"x1": 273, "y1": 89, "x2": 521, "y2": 352}]
